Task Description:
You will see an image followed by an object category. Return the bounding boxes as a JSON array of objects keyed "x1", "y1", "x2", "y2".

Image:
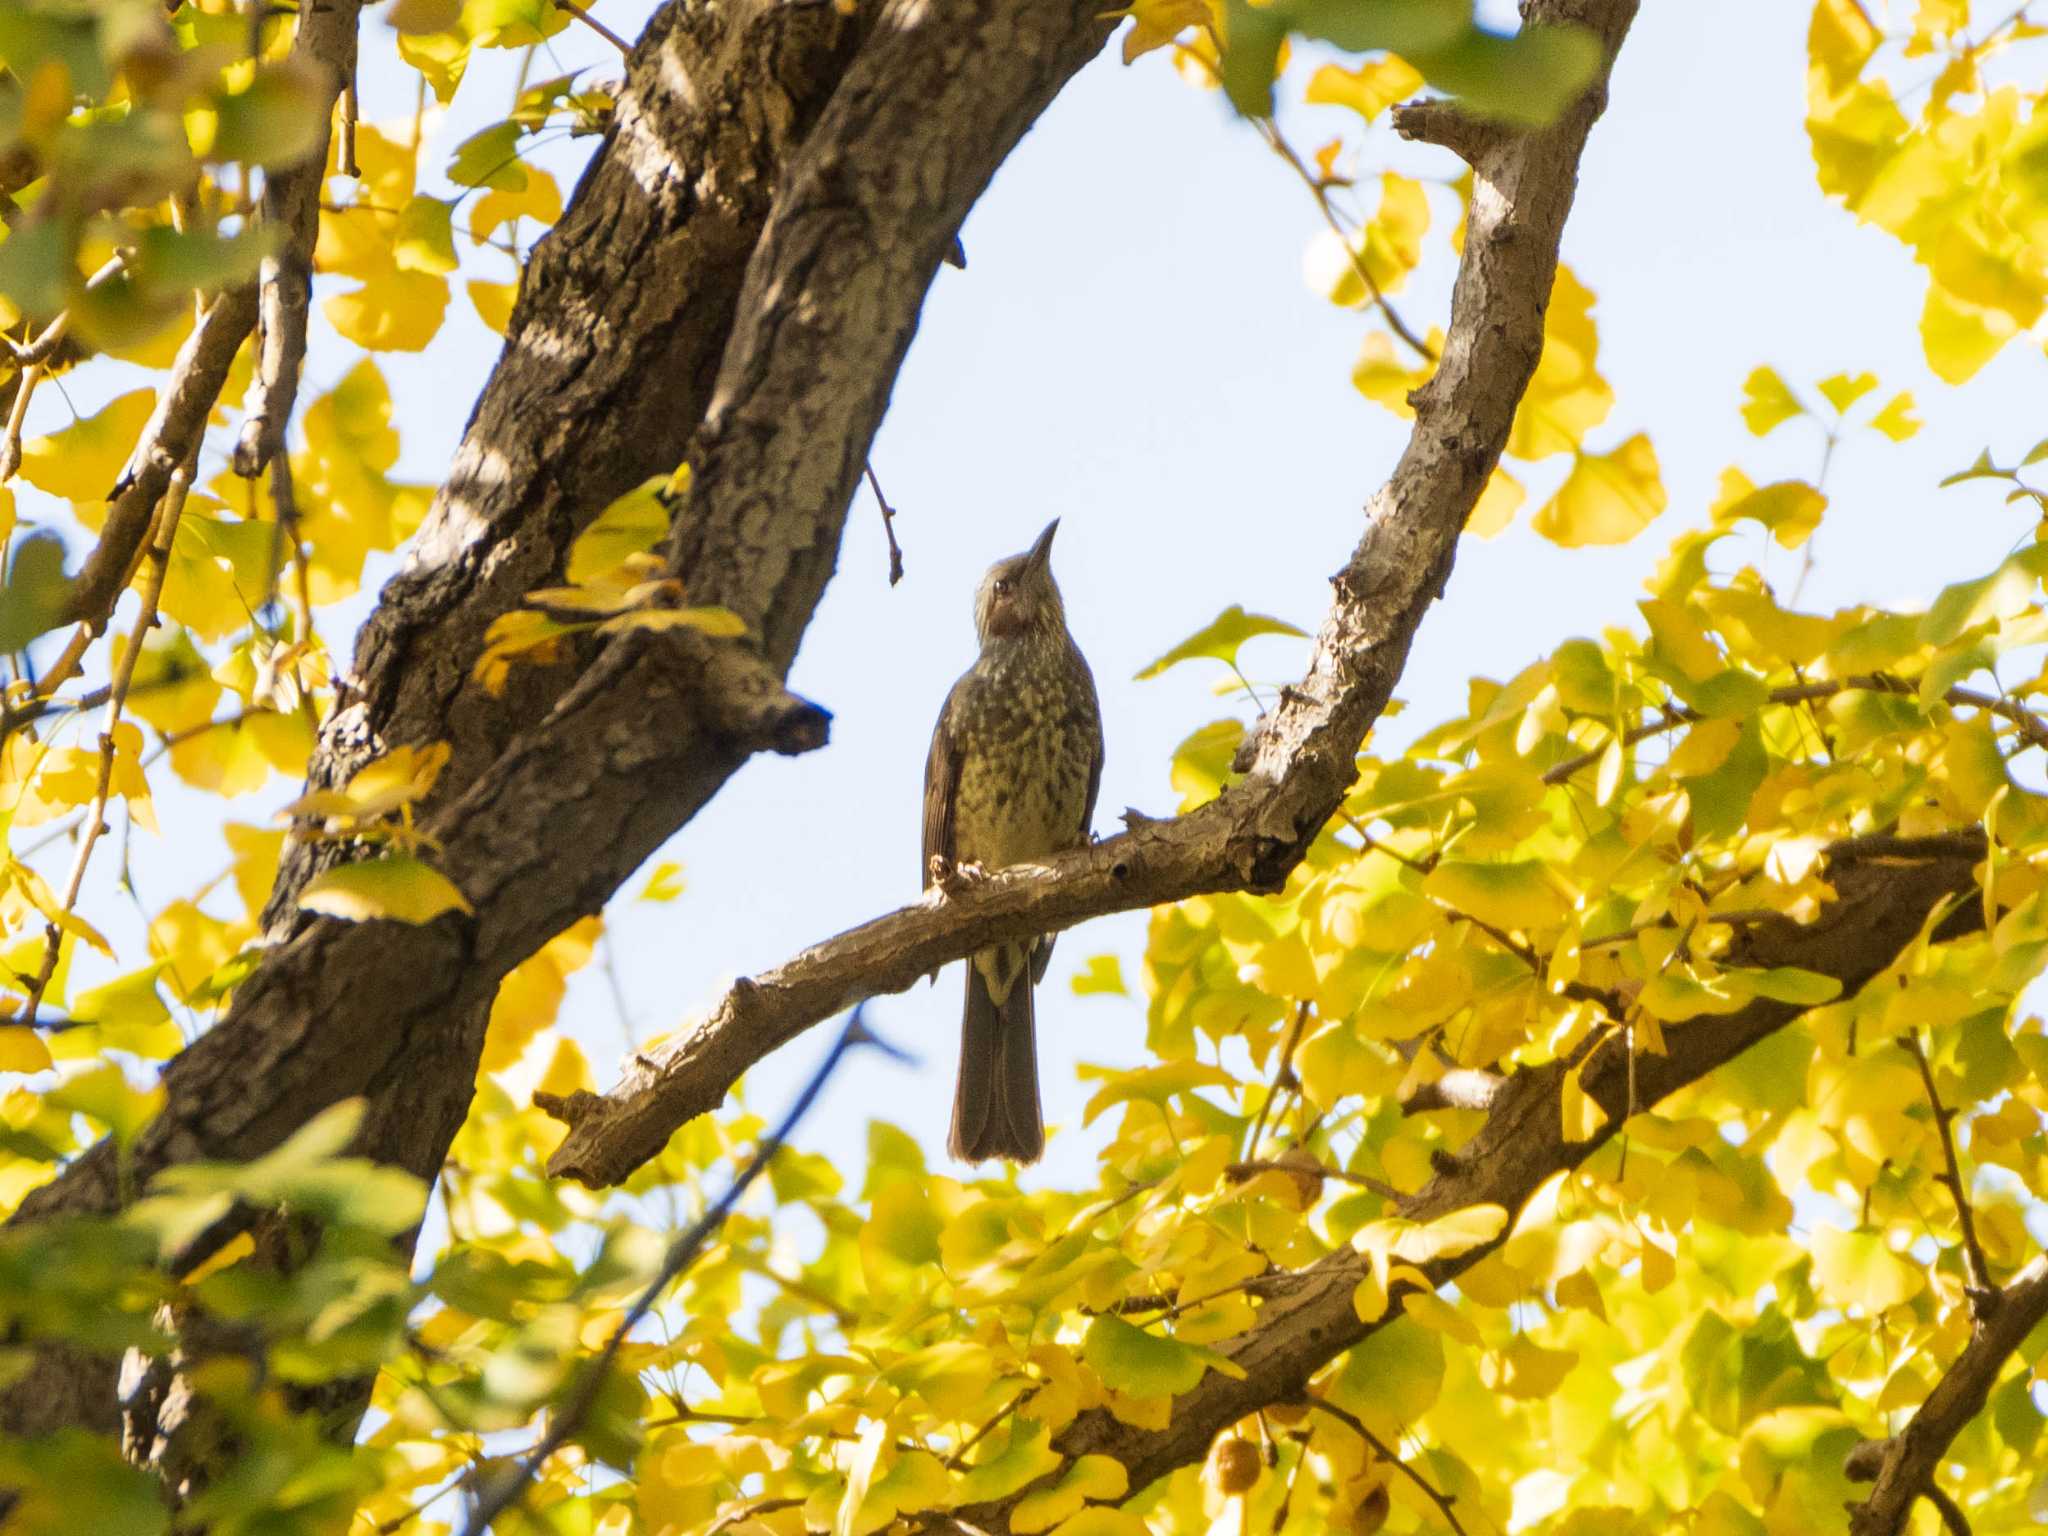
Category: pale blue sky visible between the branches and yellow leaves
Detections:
[{"x1": 25, "y1": 0, "x2": 2048, "y2": 1180}]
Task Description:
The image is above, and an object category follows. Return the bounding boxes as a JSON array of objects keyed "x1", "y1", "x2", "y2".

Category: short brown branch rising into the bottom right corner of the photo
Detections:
[{"x1": 1849, "y1": 1257, "x2": 2048, "y2": 1536}]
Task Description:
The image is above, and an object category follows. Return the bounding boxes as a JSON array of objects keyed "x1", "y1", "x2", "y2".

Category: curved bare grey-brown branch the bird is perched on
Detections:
[{"x1": 551, "y1": 0, "x2": 1636, "y2": 1184}]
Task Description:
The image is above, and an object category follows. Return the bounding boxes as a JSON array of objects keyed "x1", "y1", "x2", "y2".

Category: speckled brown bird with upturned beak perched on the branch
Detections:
[{"x1": 924, "y1": 518, "x2": 1102, "y2": 1163}]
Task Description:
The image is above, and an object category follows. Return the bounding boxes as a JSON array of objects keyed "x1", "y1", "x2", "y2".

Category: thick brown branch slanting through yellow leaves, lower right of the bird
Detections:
[{"x1": 954, "y1": 834, "x2": 2017, "y2": 1536}]
